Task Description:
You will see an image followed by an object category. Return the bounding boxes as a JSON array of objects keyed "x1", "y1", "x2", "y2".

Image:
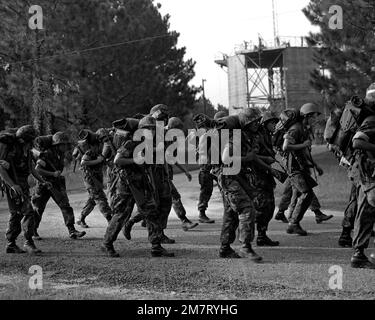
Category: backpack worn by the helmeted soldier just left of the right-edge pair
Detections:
[{"x1": 272, "y1": 109, "x2": 301, "y2": 152}]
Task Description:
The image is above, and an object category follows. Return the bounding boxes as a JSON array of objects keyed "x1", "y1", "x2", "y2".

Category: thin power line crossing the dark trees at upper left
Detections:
[{"x1": 1, "y1": 34, "x2": 173, "y2": 67}]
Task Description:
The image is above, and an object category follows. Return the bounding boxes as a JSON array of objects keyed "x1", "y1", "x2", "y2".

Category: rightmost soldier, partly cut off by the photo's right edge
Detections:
[{"x1": 351, "y1": 112, "x2": 375, "y2": 269}]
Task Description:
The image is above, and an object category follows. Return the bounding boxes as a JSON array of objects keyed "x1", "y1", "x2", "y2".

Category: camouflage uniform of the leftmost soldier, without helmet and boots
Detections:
[{"x1": 0, "y1": 132, "x2": 35, "y2": 250}]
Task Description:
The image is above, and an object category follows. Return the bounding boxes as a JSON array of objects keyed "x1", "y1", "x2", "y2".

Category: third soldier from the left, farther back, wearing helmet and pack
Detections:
[{"x1": 77, "y1": 130, "x2": 112, "y2": 228}]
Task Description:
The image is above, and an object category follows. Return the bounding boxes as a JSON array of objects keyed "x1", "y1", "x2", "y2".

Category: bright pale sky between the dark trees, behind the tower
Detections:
[{"x1": 155, "y1": 0, "x2": 315, "y2": 106}]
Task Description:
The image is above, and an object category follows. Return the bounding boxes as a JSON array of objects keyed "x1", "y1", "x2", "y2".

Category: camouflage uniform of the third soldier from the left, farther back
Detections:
[{"x1": 80, "y1": 150, "x2": 112, "y2": 221}]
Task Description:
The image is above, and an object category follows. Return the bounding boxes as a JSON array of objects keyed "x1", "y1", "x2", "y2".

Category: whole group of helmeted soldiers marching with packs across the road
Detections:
[{"x1": 0, "y1": 86, "x2": 375, "y2": 268}]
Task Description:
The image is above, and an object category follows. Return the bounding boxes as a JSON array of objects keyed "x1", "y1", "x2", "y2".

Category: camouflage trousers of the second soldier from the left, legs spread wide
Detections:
[{"x1": 32, "y1": 179, "x2": 75, "y2": 231}]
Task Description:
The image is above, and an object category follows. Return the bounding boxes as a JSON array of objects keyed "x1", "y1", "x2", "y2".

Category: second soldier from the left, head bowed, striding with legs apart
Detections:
[{"x1": 32, "y1": 132, "x2": 86, "y2": 240}]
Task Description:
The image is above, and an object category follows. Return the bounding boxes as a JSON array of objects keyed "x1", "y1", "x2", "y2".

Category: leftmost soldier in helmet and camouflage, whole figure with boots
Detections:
[{"x1": 0, "y1": 125, "x2": 49, "y2": 254}]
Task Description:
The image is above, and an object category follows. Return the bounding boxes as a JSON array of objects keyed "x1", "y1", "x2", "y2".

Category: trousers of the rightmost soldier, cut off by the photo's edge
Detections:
[{"x1": 353, "y1": 183, "x2": 375, "y2": 250}]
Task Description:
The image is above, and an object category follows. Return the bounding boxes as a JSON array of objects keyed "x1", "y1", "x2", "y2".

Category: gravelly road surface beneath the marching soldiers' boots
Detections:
[{"x1": 0, "y1": 156, "x2": 375, "y2": 299}]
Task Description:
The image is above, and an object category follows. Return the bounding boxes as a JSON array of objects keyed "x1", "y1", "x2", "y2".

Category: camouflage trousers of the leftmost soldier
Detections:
[{"x1": 6, "y1": 181, "x2": 35, "y2": 243}]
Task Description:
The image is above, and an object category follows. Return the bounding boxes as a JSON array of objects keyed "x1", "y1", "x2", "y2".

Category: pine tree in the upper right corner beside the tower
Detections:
[{"x1": 303, "y1": 0, "x2": 375, "y2": 105}]
